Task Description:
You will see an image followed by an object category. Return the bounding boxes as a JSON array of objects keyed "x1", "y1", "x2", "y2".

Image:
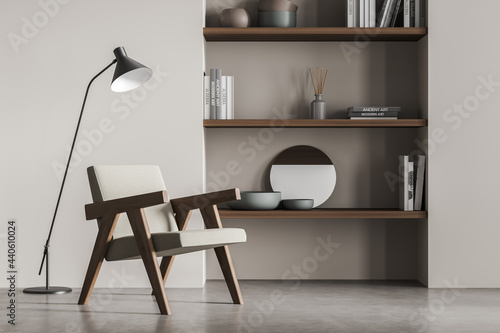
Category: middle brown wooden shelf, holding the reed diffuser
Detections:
[{"x1": 203, "y1": 119, "x2": 427, "y2": 128}]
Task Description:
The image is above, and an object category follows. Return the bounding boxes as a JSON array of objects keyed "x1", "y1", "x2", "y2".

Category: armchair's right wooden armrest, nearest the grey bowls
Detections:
[{"x1": 170, "y1": 188, "x2": 241, "y2": 213}]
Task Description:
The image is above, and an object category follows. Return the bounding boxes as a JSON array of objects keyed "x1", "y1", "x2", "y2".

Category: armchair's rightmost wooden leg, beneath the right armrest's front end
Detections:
[{"x1": 200, "y1": 205, "x2": 243, "y2": 304}]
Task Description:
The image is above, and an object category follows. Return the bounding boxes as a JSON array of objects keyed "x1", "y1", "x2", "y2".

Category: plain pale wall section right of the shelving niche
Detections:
[{"x1": 428, "y1": 0, "x2": 500, "y2": 288}]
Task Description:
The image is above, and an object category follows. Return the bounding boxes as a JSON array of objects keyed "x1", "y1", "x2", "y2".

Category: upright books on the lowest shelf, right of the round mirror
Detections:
[{"x1": 399, "y1": 155, "x2": 425, "y2": 211}]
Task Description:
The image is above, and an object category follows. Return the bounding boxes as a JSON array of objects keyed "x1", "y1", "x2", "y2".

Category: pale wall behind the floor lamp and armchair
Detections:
[{"x1": 0, "y1": 0, "x2": 204, "y2": 287}]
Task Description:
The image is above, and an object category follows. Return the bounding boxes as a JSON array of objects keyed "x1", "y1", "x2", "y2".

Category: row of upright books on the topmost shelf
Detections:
[{"x1": 347, "y1": 0, "x2": 426, "y2": 28}]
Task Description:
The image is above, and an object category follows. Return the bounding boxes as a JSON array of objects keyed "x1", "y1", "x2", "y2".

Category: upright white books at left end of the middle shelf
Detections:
[{"x1": 203, "y1": 69, "x2": 234, "y2": 119}]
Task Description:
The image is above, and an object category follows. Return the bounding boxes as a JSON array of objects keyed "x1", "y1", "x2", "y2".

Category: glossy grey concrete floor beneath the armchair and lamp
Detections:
[{"x1": 0, "y1": 281, "x2": 500, "y2": 333}]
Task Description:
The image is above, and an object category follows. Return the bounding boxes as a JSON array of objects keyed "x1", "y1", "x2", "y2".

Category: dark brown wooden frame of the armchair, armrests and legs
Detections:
[{"x1": 78, "y1": 188, "x2": 243, "y2": 315}]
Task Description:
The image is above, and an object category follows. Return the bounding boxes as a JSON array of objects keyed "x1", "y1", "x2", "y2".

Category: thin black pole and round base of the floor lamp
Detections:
[{"x1": 23, "y1": 59, "x2": 117, "y2": 294}]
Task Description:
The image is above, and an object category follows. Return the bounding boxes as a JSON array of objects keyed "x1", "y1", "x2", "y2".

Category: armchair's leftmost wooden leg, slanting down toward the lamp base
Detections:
[{"x1": 78, "y1": 214, "x2": 120, "y2": 305}]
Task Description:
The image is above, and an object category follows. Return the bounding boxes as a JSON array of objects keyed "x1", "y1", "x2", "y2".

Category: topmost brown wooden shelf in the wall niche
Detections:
[{"x1": 203, "y1": 27, "x2": 427, "y2": 42}]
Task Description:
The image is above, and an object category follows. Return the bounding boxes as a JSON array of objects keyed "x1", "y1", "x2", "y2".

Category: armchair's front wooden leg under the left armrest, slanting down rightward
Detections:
[{"x1": 127, "y1": 208, "x2": 172, "y2": 315}]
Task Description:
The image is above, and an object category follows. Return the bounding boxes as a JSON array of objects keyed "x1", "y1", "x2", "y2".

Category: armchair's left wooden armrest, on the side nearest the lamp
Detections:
[{"x1": 85, "y1": 191, "x2": 168, "y2": 220}]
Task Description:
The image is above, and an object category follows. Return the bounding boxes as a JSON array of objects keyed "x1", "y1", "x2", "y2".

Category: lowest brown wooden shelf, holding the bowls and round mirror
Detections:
[{"x1": 219, "y1": 208, "x2": 427, "y2": 219}]
